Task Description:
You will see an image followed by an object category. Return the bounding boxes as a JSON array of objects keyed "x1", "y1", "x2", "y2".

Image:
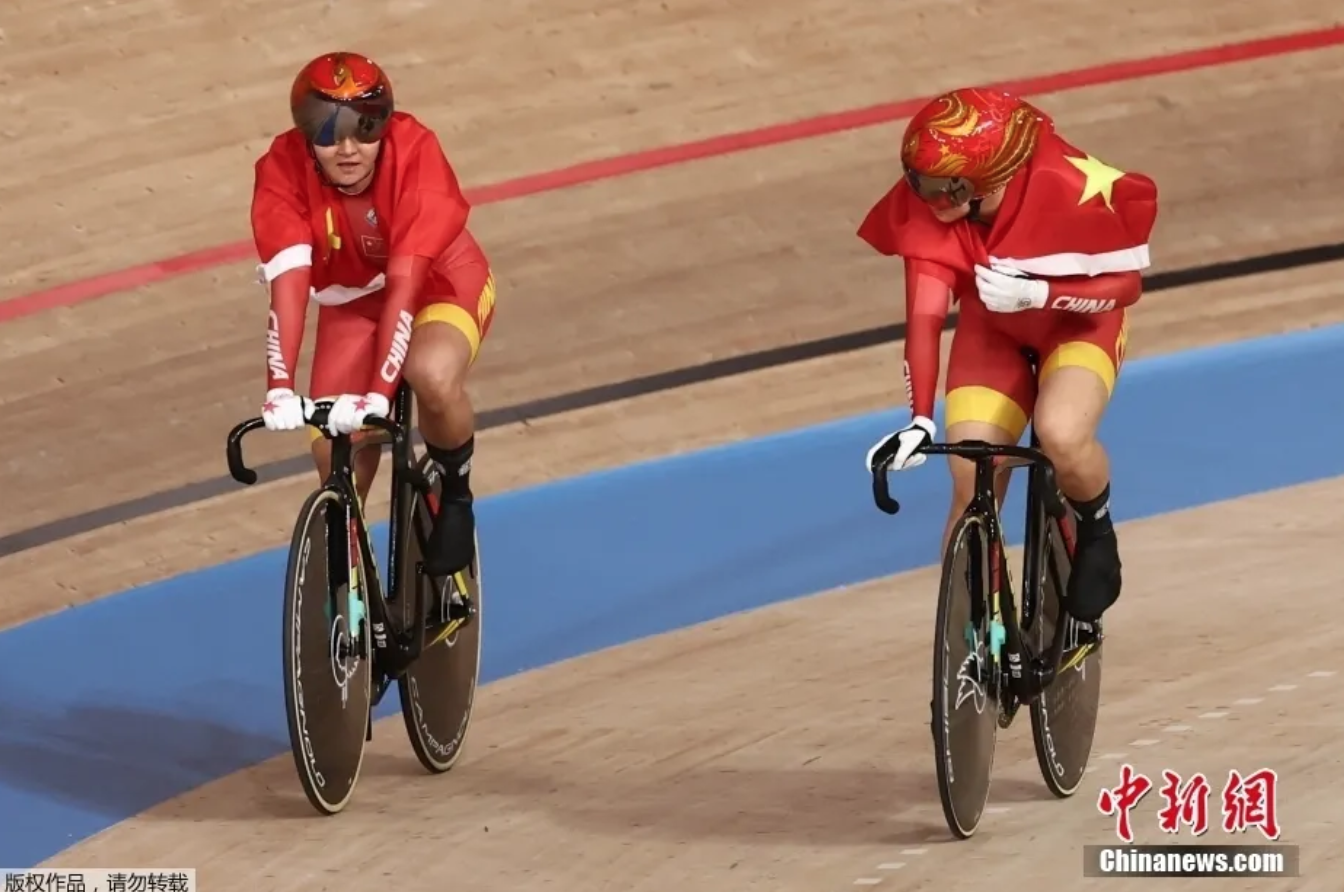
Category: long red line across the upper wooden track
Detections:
[{"x1": 0, "y1": 26, "x2": 1344, "y2": 322}]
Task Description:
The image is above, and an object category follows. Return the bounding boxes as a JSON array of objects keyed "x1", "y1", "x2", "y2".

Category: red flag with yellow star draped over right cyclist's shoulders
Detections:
[{"x1": 859, "y1": 133, "x2": 1157, "y2": 281}]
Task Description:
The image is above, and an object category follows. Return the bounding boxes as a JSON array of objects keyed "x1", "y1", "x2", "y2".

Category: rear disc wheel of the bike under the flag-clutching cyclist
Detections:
[{"x1": 1031, "y1": 519, "x2": 1102, "y2": 799}]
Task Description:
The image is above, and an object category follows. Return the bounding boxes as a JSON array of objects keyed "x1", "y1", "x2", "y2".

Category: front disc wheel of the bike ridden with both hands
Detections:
[{"x1": 284, "y1": 489, "x2": 371, "y2": 814}]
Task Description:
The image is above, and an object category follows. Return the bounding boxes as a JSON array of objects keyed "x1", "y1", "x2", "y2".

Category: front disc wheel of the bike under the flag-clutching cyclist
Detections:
[{"x1": 933, "y1": 515, "x2": 999, "y2": 840}]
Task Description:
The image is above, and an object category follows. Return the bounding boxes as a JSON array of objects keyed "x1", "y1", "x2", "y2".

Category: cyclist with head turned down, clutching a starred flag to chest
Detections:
[{"x1": 859, "y1": 89, "x2": 1157, "y2": 622}]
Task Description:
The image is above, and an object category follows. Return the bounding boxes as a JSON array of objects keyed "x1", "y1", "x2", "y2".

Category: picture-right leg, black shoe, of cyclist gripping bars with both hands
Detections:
[{"x1": 403, "y1": 258, "x2": 495, "y2": 576}]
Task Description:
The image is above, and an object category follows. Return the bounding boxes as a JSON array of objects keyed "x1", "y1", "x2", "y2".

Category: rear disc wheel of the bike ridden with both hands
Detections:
[{"x1": 396, "y1": 458, "x2": 481, "y2": 774}]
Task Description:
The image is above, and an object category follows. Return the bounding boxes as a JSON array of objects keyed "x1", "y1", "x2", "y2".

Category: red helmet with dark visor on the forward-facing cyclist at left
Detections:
[{"x1": 289, "y1": 52, "x2": 395, "y2": 145}]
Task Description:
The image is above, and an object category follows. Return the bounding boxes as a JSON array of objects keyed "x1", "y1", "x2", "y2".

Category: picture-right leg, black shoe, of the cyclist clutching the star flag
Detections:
[{"x1": 1034, "y1": 310, "x2": 1128, "y2": 621}]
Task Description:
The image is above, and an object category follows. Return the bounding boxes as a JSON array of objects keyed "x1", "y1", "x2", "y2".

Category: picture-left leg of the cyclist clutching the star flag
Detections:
[{"x1": 942, "y1": 306, "x2": 1036, "y2": 551}]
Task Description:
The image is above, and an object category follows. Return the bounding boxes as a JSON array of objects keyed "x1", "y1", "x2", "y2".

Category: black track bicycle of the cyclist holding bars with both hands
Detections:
[{"x1": 226, "y1": 384, "x2": 481, "y2": 814}]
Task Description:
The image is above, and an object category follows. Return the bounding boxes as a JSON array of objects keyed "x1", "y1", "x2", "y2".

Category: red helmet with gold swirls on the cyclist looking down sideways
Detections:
[{"x1": 900, "y1": 89, "x2": 1054, "y2": 208}]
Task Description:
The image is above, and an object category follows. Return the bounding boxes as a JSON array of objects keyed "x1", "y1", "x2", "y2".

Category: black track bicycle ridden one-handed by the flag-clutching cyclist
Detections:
[{"x1": 872, "y1": 356, "x2": 1103, "y2": 840}]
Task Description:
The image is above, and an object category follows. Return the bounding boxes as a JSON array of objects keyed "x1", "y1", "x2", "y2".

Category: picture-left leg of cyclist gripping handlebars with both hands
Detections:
[{"x1": 308, "y1": 298, "x2": 382, "y2": 501}]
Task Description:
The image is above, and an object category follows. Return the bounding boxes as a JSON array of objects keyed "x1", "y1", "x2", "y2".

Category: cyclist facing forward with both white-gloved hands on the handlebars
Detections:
[{"x1": 251, "y1": 52, "x2": 495, "y2": 576}]
